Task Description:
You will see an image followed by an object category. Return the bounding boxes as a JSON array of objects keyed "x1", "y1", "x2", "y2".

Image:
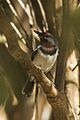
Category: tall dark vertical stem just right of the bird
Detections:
[{"x1": 55, "y1": 0, "x2": 73, "y2": 92}]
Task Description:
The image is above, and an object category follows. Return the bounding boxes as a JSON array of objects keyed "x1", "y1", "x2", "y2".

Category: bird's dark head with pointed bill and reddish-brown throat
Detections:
[{"x1": 35, "y1": 31, "x2": 58, "y2": 54}]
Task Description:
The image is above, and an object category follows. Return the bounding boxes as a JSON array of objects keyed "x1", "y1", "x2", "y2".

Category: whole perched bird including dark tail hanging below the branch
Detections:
[{"x1": 22, "y1": 31, "x2": 59, "y2": 96}]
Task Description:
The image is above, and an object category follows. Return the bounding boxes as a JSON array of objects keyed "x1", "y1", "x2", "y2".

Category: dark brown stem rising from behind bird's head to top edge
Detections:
[{"x1": 41, "y1": 0, "x2": 56, "y2": 35}]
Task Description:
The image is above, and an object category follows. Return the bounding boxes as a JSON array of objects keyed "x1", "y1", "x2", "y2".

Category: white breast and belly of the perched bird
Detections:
[{"x1": 33, "y1": 50, "x2": 58, "y2": 72}]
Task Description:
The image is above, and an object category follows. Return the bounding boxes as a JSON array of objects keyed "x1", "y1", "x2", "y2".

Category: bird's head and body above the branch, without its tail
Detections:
[{"x1": 31, "y1": 31, "x2": 59, "y2": 73}]
